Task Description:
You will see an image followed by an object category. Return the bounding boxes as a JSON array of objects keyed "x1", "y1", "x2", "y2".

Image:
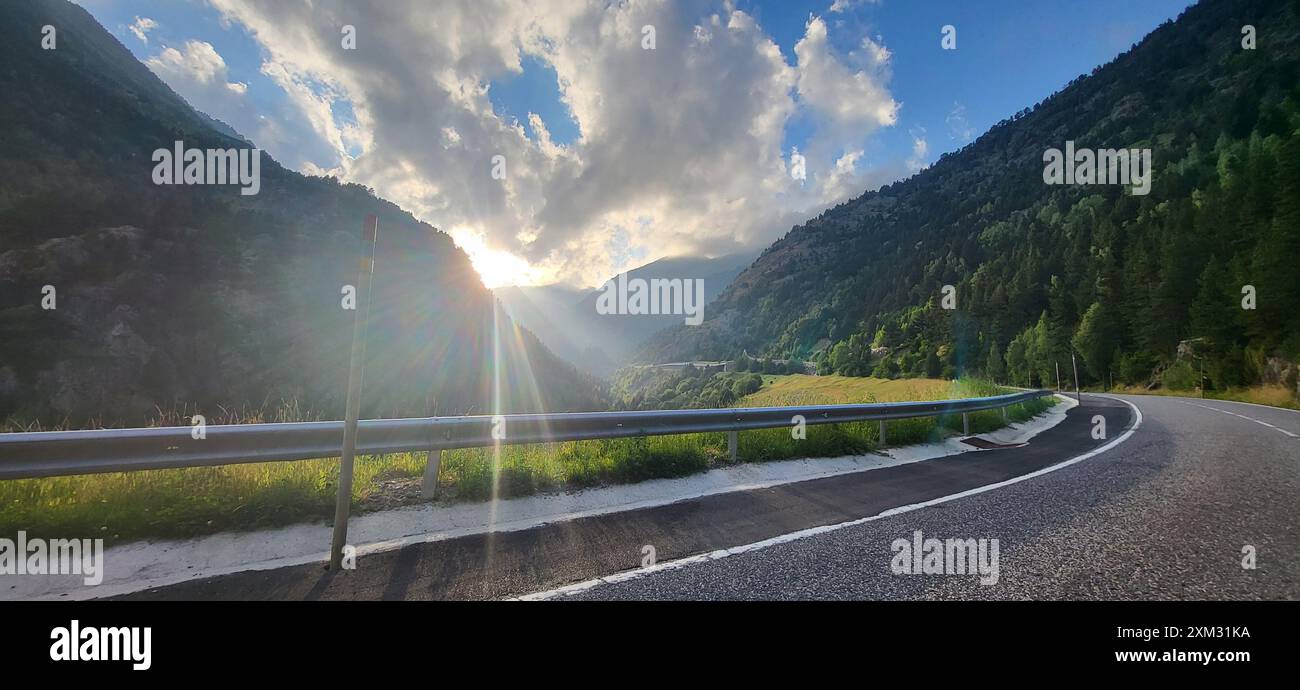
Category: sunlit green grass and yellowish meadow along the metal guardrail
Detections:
[{"x1": 0, "y1": 374, "x2": 1052, "y2": 543}]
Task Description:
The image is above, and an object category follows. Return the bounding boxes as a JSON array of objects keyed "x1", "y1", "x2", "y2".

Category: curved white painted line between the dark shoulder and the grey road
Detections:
[{"x1": 511, "y1": 395, "x2": 1143, "y2": 602}]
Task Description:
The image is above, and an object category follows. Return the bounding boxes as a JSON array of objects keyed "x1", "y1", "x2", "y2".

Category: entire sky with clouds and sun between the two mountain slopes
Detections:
[{"x1": 78, "y1": 0, "x2": 1190, "y2": 287}]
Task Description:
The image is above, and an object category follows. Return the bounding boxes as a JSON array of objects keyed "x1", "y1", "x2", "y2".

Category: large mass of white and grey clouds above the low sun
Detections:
[{"x1": 195, "y1": 0, "x2": 904, "y2": 285}]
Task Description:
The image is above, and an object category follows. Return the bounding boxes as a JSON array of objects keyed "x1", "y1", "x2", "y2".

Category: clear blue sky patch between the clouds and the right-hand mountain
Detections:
[{"x1": 740, "y1": 0, "x2": 1193, "y2": 175}]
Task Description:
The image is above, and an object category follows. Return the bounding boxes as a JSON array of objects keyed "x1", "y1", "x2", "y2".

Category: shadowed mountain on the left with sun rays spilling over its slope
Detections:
[{"x1": 0, "y1": 0, "x2": 607, "y2": 424}]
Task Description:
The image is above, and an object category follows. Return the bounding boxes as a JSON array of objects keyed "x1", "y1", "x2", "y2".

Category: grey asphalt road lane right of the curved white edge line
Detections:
[{"x1": 575, "y1": 396, "x2": 1300, "y2": 599}]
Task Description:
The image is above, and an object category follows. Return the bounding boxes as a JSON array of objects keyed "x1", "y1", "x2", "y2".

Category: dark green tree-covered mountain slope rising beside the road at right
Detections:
[{"x1": 645, "y1": 0, "x2": 1300, "y2": 386}]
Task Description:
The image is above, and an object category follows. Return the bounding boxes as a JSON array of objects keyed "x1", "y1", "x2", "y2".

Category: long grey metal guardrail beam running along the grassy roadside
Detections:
[{"x1": 0, "y1": 390, "x2": 1052, "y2": 479}]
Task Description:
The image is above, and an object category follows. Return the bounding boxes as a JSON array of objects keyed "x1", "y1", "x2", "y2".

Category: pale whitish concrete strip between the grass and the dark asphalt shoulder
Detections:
[{"x1": 15, "y1": 398, "x2": 1074, "y2": 602}]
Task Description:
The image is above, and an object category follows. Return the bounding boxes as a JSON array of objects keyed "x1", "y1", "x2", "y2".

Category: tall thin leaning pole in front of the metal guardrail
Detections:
[{"x1": 329, "y1": 216, "x2": 380, "y2": 570}]
